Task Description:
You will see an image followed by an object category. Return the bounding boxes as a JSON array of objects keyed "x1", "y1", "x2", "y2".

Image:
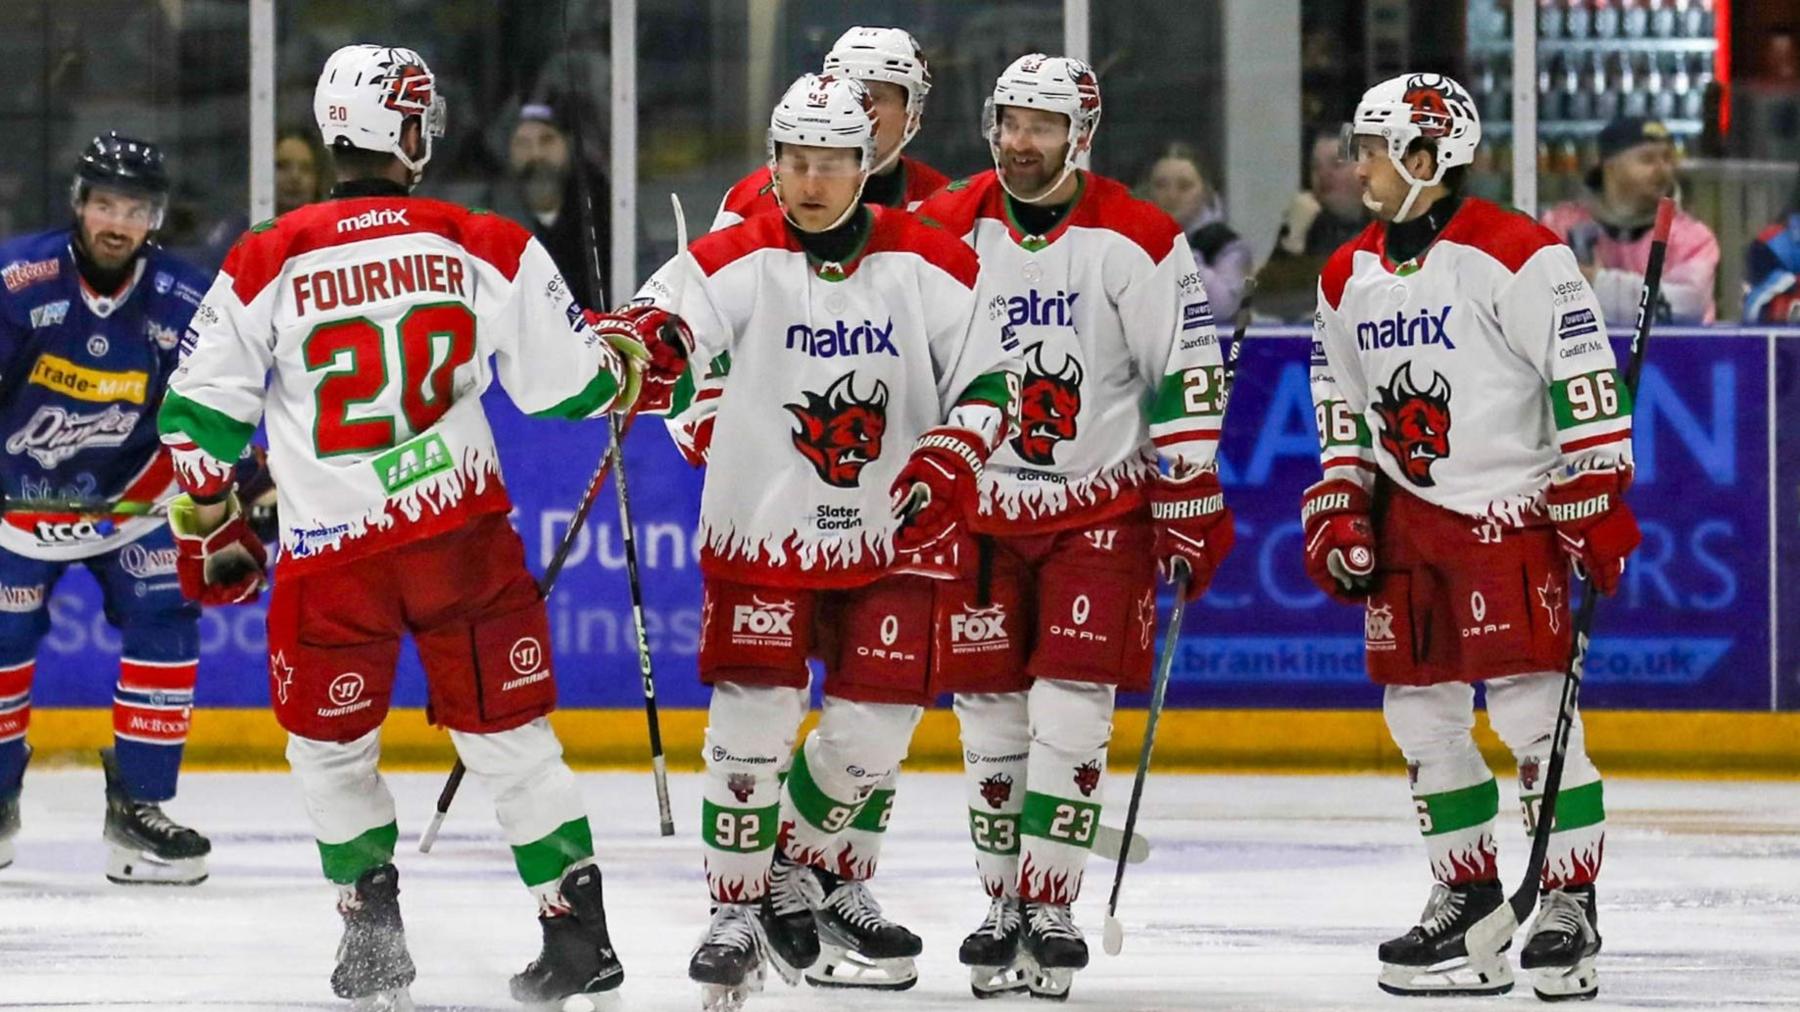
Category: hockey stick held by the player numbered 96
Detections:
[{"x1": 1469, "y1": 196, "x2": 1676, "y2": 953}]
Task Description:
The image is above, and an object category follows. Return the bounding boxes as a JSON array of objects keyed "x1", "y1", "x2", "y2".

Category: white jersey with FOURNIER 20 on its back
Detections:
[{"x1": 158, "y1": 189, "x2": 623, "y2": 569}]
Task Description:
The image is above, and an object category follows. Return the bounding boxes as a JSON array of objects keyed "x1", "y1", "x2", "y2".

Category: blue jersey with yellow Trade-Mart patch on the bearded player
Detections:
[{"x1": 0, "y1": 229, "x2": 211, "y2": 560}]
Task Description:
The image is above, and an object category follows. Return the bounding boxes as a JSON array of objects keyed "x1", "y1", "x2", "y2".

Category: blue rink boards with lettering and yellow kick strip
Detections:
[{"x1": 32, "y1": 328, "x2": 1800, "y2": 773}]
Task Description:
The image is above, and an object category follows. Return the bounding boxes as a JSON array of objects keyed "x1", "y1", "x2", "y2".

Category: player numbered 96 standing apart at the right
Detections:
[{"x1": 1301, "y1": 74, "x2": 1638, "y2": 999}]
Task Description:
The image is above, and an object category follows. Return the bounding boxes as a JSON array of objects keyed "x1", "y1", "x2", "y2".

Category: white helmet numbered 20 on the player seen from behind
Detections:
[{"x1": 313, "y1": 45, "x2": 445, "y2": 175}]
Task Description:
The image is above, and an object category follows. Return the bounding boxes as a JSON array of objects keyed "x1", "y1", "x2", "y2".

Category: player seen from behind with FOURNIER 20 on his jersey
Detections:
[{"x1": 160, "y1": 45, "x2": 684, "y2": 1008}]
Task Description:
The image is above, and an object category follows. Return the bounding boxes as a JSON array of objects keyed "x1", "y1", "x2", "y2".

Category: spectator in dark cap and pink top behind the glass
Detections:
[{"x1": 1543, "y1": 115, "x2": 1719, "y2": 326}]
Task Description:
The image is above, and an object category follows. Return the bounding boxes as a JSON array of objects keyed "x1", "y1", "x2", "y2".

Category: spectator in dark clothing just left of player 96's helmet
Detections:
[{"x1": 1256, "y1": 126, "x2": 1368, "y2": 321}]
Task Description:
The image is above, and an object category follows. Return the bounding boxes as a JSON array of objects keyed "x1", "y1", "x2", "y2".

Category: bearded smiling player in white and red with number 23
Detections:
[{"x1": 920, "y1": 54, "x2": 1233, "y2": 998}]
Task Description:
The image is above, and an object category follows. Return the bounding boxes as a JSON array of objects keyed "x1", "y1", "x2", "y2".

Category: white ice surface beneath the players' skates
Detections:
[{"x1": 0, "y1": 769, "x2": 1800, "y2": 1012}]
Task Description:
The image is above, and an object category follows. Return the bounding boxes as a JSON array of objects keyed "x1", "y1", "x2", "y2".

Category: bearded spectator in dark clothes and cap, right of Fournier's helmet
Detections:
[{"x1": 486, "y1": 103, "x2": 612, "y2": 310}]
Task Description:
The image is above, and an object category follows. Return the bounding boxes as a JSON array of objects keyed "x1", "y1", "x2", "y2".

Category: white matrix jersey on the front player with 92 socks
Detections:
[{"x1": 637, "y1": 207, "x2": 1019, "y2": 589}]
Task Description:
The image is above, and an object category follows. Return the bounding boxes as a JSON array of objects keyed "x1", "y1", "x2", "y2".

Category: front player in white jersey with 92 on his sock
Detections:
[{"x1": 612, "y1": 74, "x2": 1017, "y2": 1008}]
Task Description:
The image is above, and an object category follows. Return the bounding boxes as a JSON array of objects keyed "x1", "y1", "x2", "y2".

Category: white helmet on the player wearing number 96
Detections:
[{"x1": 1345, "y1": 74, "x2": 1481, "y2": 221}]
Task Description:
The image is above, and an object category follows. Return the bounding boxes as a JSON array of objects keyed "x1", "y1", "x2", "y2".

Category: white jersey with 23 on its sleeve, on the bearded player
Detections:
[{"x1": 918, "y1": 171, "x2": 1224, "y2": 533}]
